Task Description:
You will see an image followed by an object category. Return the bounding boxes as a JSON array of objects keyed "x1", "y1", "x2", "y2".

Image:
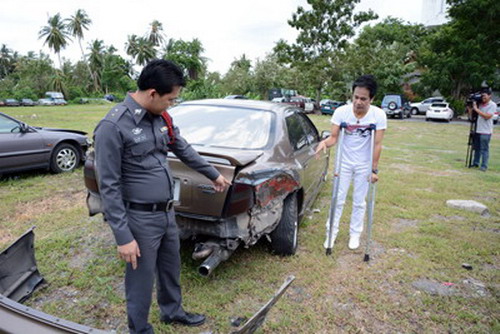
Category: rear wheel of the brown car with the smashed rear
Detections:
[{"x1": 271, "y1": 194, "x2": 299, "y2": 255}]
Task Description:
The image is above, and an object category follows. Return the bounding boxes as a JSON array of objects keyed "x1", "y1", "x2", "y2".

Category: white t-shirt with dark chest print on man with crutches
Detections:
[{"x1": 331, "y1": 104, "x2": 387, "y2": 165}]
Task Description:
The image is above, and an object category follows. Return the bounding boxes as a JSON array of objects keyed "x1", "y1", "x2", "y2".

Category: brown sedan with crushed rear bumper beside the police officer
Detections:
[{"x1": 84, "y1": 99, "x2": 329, "y2": 275}]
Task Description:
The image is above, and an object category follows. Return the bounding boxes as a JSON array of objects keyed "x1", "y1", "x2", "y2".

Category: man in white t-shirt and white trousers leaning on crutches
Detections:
[{"x1": 316, "y1": 75, "x2": 387, "y2": 254}]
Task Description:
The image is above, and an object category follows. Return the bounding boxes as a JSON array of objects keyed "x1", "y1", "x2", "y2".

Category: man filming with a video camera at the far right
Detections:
[{"x1": 467, "y1": 88, "x2": 496, "y2": 172}]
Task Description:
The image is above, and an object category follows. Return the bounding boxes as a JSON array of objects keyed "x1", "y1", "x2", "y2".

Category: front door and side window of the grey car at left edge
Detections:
[{"x1": 0, "y1": 115, "x2": 50, "y2": 172}]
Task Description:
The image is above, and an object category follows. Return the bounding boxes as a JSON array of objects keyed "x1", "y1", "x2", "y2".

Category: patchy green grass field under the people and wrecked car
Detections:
[{"x1": 0, "y1": 105, "x2": 500, "y2": 333}]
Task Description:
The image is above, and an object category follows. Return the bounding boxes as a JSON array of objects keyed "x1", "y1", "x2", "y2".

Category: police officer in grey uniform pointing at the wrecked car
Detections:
[{"x1": 95, "y1": 60, "x2": 230, "y2": 333}]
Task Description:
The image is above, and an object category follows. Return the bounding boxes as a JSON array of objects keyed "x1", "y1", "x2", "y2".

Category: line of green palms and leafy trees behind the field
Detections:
[{"x1": 0, "y1": 0, "x2": 500, "y2": 111}]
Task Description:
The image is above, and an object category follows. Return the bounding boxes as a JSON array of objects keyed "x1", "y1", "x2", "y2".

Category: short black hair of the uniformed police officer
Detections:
[{"x1": 137, "y1": 59, "x2": 186, "y2": 95}]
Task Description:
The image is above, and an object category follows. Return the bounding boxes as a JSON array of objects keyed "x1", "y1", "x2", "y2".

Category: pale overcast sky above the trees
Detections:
[{"x1": 0, "y1": 0, "x2": 430, "y2": 74}]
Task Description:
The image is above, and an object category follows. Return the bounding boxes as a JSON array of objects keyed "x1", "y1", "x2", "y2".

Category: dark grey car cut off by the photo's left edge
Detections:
[{"x1": 0, "y1": 112, "x2": 90, "y2": 174}]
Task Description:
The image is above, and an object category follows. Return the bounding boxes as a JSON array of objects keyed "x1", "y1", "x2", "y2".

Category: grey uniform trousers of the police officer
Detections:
[{"x1": 125, "y1": 210, "x2": 184, "y2": 333}]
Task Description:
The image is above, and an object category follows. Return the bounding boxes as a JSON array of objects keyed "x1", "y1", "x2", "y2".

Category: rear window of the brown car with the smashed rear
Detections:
[{"x1": 169, "y1": 105, "x2": 274, "y2": 149}]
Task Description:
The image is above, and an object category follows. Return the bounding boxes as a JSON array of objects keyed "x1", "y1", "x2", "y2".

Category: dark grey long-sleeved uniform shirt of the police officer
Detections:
[{"x1": 95, "y1": 95, "x2": 220, "y2": 245}]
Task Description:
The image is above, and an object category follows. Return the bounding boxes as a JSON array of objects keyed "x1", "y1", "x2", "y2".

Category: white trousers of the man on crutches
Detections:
[{"x1": 326, "y1": 164, "x2": 371, "y2": 241}]
